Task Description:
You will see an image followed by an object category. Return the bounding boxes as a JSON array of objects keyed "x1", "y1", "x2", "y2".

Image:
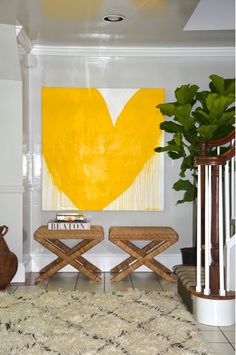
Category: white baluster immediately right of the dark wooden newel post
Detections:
[{"x1": 219, "y1": 165, "x2": 225, "y2": 296}]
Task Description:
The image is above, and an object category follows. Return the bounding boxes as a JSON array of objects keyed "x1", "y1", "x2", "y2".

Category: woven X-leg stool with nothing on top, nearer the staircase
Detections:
[{"x1": 109, "y1": 227, "x2": 178, "y2": 282}]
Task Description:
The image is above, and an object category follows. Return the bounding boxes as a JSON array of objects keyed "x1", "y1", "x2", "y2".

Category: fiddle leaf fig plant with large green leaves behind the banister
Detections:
[{"x1": 155, "y1": 74, "x2": 235, "y2": 204}]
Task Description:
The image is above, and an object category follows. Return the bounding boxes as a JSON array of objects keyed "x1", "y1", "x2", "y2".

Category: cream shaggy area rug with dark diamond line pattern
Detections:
[{"x1": 0, "y1": 290, "x2": 210, "y2": 355}]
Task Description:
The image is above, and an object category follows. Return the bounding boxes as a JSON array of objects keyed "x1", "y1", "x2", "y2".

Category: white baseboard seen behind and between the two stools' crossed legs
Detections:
[{"x1": 31, "y1": 253, "x2": 182, "y2": 272}]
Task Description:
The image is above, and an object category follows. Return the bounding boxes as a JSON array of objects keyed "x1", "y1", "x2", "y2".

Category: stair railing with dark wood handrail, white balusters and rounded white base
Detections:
[{"x1": 189, "y1": 131, "x2": 236, "y2": 326}]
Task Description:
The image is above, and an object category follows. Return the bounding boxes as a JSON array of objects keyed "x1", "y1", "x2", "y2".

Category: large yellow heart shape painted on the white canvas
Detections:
[{"x1": 42, "y1": 88, "x2": 164, "y2": 210}]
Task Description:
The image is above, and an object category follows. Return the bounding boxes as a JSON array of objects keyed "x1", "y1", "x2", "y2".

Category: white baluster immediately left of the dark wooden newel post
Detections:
[{"x1": 204, "y1": 165, "x2": 211, "y2": 295}]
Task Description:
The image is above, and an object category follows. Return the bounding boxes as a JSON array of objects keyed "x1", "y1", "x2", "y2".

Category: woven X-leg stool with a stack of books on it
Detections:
[{"x1": 34, "y1": 226, "x2": 104, "y2": 284}]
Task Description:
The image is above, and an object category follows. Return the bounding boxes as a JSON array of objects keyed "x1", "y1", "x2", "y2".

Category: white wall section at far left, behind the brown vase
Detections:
[{"x1": 0, "y1": 25, "x2": 24, "y2": 281}]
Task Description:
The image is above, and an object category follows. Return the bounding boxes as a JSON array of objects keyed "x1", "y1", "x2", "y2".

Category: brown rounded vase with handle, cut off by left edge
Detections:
[{"x1": 0, "y1": 226, "x2": 18, "y2": 290}]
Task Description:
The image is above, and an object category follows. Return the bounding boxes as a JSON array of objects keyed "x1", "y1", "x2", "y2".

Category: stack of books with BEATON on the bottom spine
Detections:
[{"x1": 48, "y1": 213, "x2": 90, "y2": 230}]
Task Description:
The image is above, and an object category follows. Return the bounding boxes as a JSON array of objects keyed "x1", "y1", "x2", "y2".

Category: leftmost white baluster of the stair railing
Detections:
[{"x1": 196, "y1": 165, "x2": 202, "y2": 292}]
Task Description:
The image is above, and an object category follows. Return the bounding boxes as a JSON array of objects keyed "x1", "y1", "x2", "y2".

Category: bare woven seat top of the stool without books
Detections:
[{"x1": 109, "y1": 226, "x2": 178, "y2": 241}]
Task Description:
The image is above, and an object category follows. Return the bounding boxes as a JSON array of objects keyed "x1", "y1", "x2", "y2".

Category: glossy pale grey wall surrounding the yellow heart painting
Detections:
[{"x1": 29, "y1": 50, "x2": 234, "y2": 271}]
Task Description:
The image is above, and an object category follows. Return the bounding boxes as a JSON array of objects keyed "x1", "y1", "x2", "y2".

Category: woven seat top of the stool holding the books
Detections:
[{"x1": 34, "y1": 226, "x2": 104, "y2": 240}]
